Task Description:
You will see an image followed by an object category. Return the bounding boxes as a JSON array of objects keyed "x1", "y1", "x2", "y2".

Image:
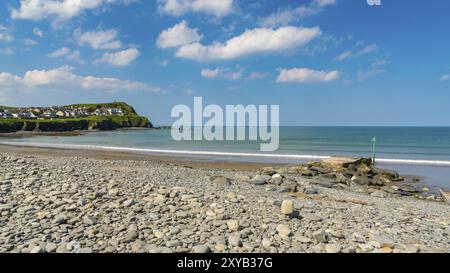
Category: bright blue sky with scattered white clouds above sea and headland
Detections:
[{"x1": 0, "y1": 0, "x2": 450, "y2": 126}]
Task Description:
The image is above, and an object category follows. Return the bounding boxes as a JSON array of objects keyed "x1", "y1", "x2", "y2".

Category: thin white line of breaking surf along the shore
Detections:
[{"x1": 0, "y1": 141, "x2": 450, "y2": 167}]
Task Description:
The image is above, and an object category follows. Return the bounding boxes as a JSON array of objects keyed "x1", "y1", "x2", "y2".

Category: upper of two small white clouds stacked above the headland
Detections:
[{"x1": 74, "y1": 29, "x2": 122, "y2": 50}]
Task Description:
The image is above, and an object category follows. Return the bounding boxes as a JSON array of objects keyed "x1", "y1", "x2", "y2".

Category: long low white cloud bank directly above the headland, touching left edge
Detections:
[{"x1": 0, "y1": 66, "x2": 162, "y2": 92}]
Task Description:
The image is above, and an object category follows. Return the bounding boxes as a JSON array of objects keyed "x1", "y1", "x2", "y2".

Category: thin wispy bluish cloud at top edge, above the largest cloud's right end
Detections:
[{"x1": 259, "y1": 0, "x2": 336, "y2": 27}]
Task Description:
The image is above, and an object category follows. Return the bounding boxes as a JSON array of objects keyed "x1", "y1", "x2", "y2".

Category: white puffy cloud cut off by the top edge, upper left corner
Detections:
[{"x1": 11, "y1": 0, "x2": 135, "y2": 26}]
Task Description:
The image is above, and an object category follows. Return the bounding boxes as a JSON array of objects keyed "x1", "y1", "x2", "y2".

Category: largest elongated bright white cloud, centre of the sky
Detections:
[{"x1": 176, "y1": 27, "x2": 321, "y2": 61}]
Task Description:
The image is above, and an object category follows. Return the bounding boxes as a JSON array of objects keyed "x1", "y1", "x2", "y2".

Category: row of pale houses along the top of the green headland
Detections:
[{"x1": 0, "y1": 107, "x2": 124, "y2": 119}]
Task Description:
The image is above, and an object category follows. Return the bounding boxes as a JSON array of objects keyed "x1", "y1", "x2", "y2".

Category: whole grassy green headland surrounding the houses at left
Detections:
[{"x1": 0, "y1": 102, "x2": 153, "y2": 133}]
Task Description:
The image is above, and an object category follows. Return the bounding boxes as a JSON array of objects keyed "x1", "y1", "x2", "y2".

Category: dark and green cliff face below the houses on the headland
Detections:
[{"x1": 0, "y1": 103, "x2": 153, "y2": 133}]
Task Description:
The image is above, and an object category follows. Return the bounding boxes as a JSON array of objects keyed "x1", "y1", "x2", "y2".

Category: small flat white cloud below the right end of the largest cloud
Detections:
[{"x1": 277, "y1": 68, "x2": 340, "y2": 83}]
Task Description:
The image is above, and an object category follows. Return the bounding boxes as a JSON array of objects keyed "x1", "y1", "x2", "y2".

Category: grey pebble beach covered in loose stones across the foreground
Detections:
[{"x1": 0, "y1": 143, "x2": 450, "y2": 253}]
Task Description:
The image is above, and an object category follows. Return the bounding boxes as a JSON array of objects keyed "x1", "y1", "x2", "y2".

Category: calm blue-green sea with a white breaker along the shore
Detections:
[{"x1": 0, "y1": 127, "x2": 450, "y2": 189}]
